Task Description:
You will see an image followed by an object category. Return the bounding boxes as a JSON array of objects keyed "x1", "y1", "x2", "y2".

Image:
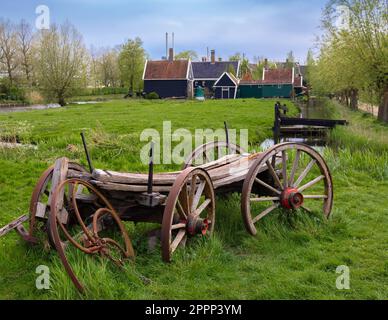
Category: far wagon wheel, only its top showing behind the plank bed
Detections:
[{"x1": 182, "y1": 141, "x2": 244, "y2": 170}]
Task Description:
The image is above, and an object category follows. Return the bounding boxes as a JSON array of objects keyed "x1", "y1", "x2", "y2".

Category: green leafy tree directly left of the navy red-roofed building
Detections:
[{"x1": 119, "y1": 38, "x2": 146, "y2": 93}]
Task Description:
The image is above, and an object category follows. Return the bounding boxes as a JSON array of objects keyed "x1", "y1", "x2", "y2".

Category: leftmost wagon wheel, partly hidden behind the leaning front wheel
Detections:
[{"x1": 29, "y1": 162, "x2": 86, "y2": 241}]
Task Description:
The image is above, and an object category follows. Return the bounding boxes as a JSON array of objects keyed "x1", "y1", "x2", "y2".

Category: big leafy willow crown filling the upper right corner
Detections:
[{"x1": 323, "y1": 0, "x2": 388, "y2": 122}]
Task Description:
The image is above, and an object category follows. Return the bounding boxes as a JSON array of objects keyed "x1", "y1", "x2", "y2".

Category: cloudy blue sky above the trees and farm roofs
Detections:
[{"x1": 0, "y1": 0, "x2": 326, "y2": 62}]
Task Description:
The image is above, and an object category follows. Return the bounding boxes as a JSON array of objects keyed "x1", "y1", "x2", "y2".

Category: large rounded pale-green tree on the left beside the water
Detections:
[{"x1": 34, "y1": 23, "x2": 86, "y2": 105}]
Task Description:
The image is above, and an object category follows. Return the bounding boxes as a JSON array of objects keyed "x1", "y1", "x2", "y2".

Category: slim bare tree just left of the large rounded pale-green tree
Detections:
[{"x1": 17, "y1": 20, "x2": 33, "y2": 83}]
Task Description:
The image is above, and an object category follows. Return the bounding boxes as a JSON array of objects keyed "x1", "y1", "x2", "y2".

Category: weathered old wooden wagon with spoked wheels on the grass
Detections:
[{"x1": 0, "y1": 130, "x2": 333, "y2": 291}]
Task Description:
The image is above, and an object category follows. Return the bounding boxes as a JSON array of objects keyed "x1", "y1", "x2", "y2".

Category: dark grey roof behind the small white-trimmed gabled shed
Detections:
[{"x1": 192, "y1": 61, "x2": 240, "y2": 80}]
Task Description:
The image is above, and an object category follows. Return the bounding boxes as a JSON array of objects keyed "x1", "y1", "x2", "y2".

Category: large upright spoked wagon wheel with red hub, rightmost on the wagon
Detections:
[{"x1": 241, "y1": 143, "x2": 333, "y2": 235}]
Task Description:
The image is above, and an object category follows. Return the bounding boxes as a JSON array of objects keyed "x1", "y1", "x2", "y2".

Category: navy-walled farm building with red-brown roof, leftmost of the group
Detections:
[{"x1": 143, "y1": 49, "x2": 193, "y2": 99}]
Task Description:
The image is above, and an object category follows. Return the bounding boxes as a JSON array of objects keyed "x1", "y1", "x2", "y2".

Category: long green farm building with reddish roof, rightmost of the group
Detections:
[{"x1": 238, "y1": 68, "x2": 303, "y2": 98}]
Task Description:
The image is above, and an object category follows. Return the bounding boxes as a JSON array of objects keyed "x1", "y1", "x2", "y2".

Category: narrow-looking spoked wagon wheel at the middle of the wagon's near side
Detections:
[{"x1": 162, "y1": 168, "x2": 215, "y2": 262}]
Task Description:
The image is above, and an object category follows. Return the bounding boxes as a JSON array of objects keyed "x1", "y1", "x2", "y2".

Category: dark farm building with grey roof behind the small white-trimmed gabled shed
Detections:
[{"x1": 192, "y1": 50, "x2": 240, "y2": 97}]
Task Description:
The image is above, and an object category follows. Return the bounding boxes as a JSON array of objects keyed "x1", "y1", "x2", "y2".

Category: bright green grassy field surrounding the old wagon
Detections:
[{"x1": 0, "y1": 100, "x2": 388, "y2": 299}]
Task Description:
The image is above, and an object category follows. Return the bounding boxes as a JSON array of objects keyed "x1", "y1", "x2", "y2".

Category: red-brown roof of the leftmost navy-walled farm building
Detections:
[{"x1": 143, "y1": 60, "x2": 190, "y2": 80}]
